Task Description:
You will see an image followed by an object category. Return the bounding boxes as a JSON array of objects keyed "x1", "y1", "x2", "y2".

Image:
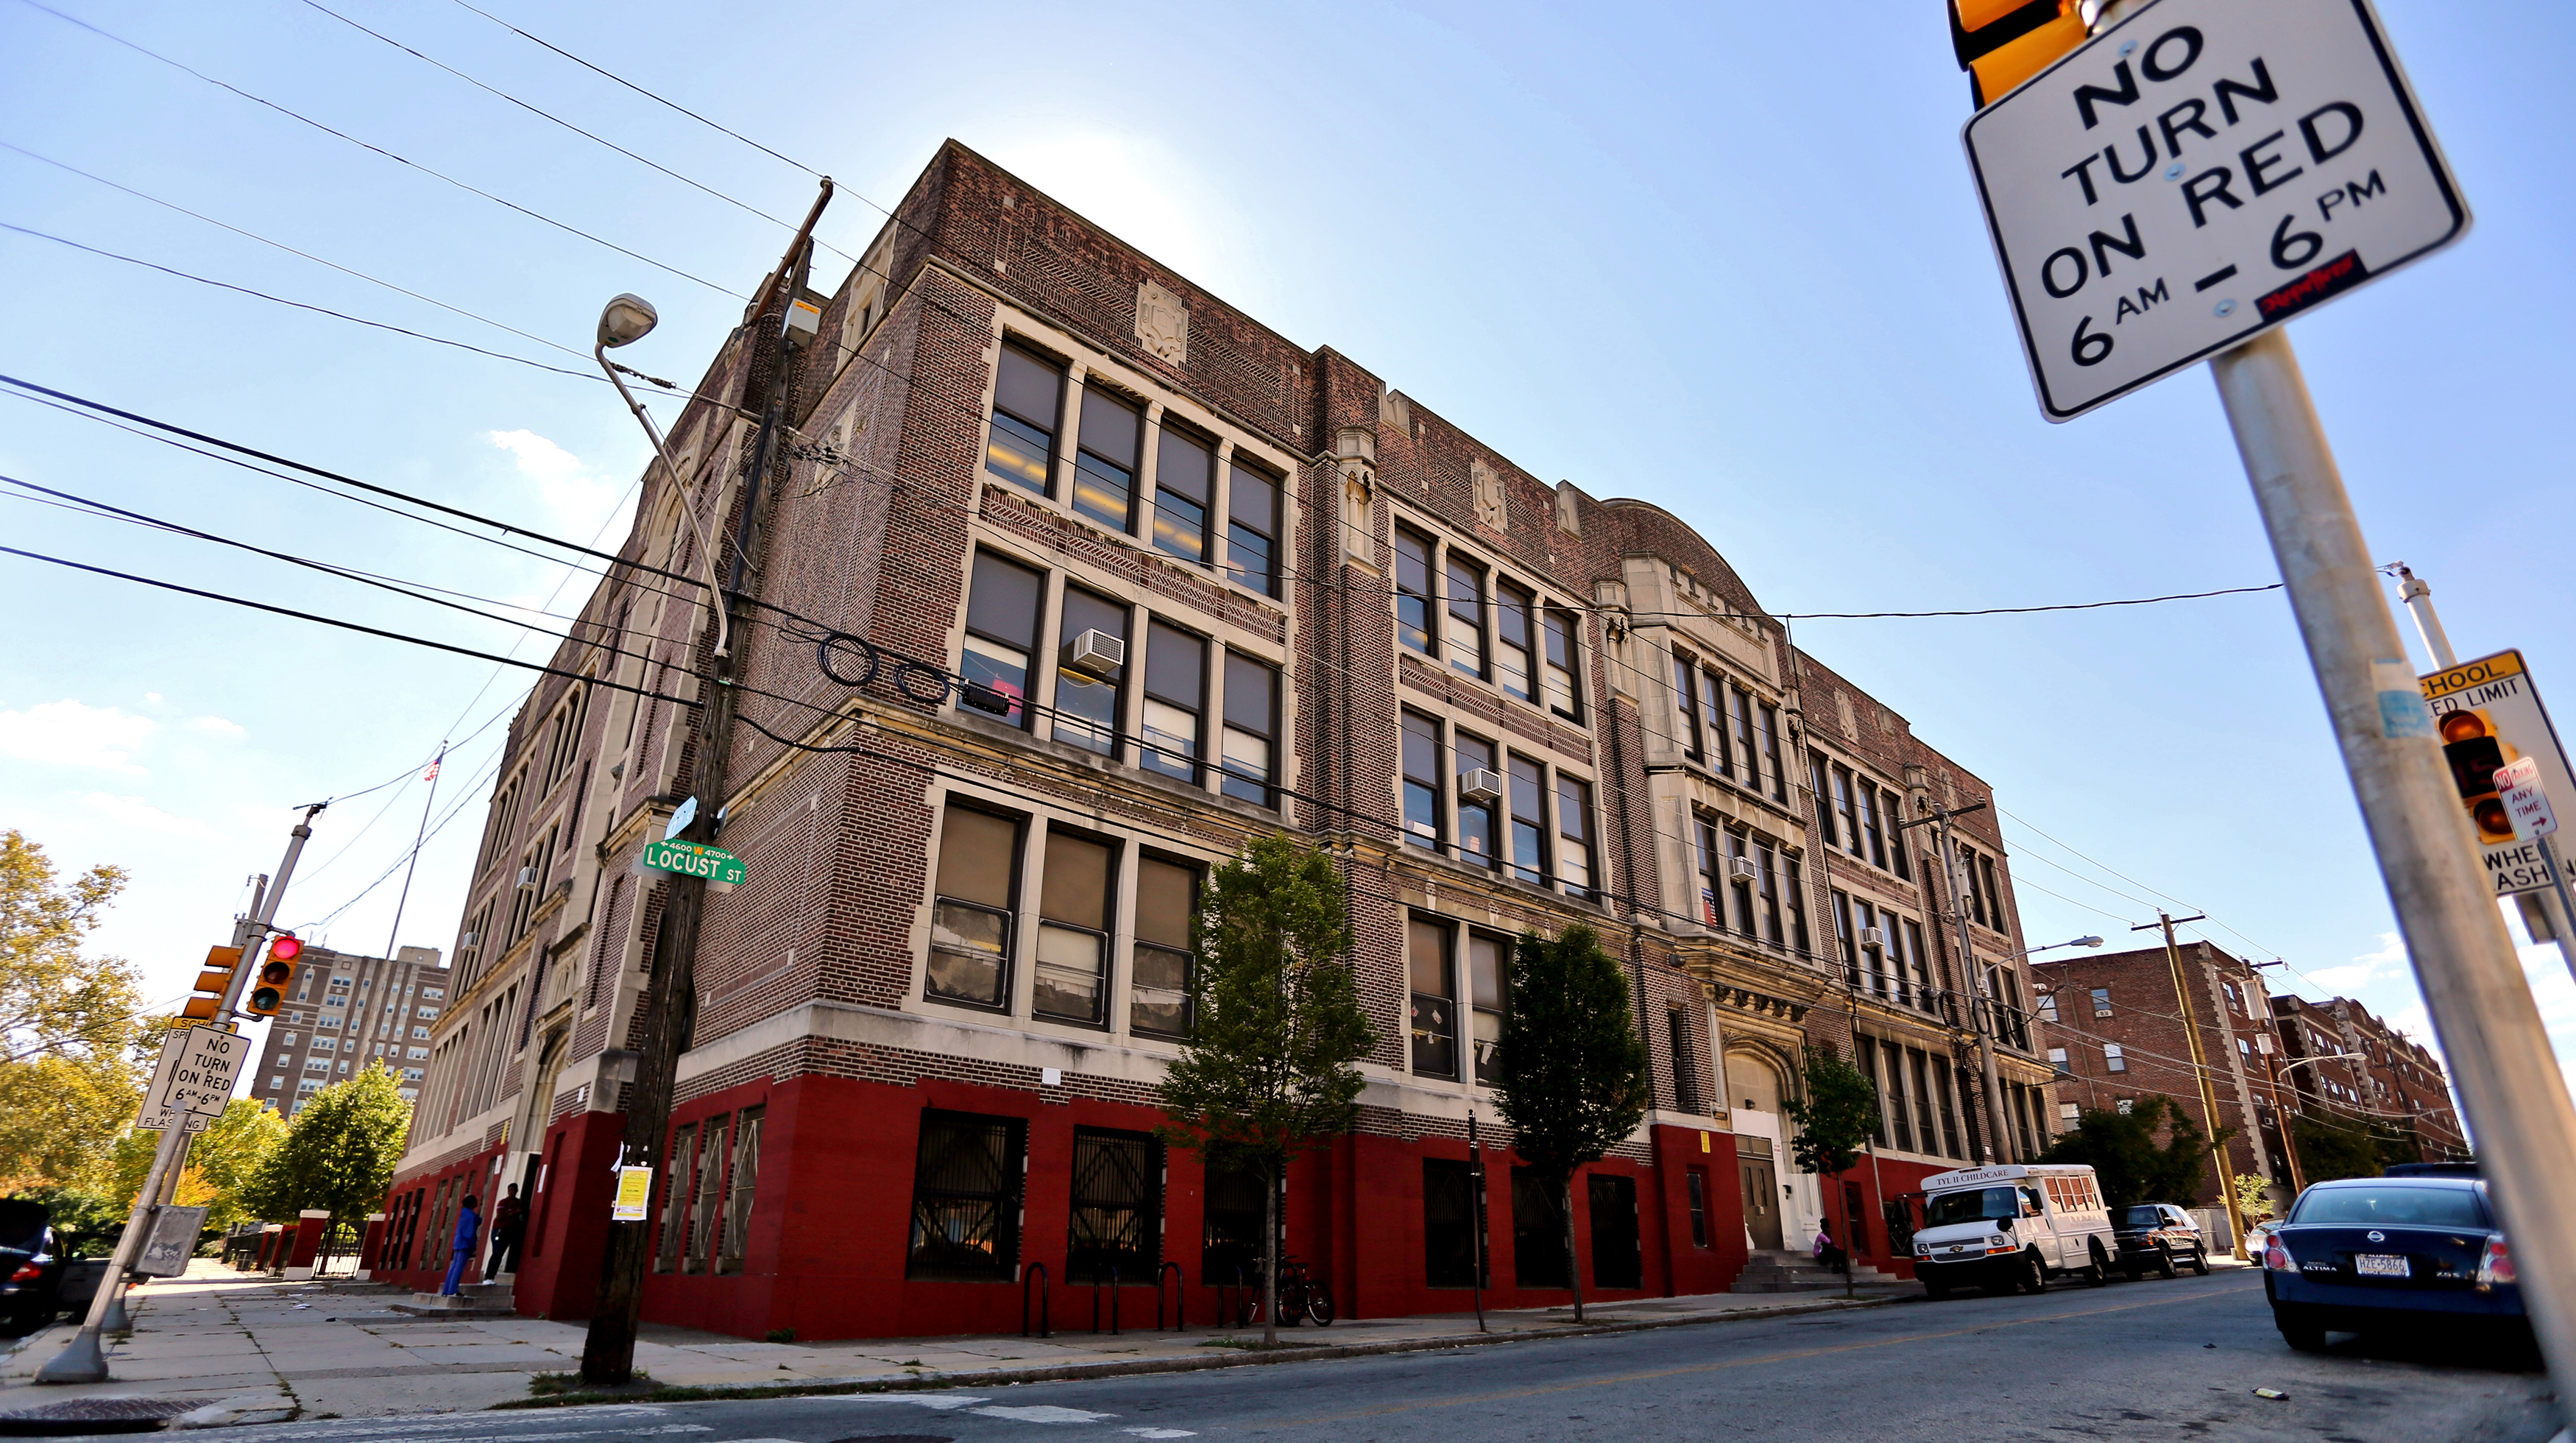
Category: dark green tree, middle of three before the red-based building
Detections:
[{"x1": 1494, "y1": 925, "x2": 1654, "y2": 1322}]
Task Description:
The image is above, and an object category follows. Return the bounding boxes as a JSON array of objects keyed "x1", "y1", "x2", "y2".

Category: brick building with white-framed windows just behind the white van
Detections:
[{"x1": 2033, "y1": 943, "x2": 2296, "y2": 1209}]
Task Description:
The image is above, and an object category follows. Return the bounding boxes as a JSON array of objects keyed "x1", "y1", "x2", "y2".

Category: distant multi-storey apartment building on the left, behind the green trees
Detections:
[{"x1": 250, "y1": 946, "x2": 448, "y2": 1116}]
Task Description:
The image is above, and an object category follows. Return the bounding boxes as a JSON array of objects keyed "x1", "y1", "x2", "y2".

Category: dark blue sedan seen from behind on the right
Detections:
[{"x1": 2262, "y1": 1168, "x2": 2530, "y2": 1350}]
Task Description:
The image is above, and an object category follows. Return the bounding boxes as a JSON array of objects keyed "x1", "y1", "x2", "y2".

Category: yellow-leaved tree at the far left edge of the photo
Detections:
[{"x1": 0, "y1": 830, "x2": 160, "y2": 1188}]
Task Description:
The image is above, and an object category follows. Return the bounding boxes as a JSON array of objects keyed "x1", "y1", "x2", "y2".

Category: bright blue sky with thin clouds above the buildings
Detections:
[{"x1": 0, "y1": 0, "x2": 2576, "y2": 1103}]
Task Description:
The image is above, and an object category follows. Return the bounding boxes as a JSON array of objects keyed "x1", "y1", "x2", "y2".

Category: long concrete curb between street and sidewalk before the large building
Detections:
[{"x1": 489, "y1": 1296, "x2": 1906, "y2": 1412}]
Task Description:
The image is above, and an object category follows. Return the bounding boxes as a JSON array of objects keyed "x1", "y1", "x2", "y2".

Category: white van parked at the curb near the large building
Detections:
[{"x1": 1914, "y1": 1162, "x2": 2120, "y2": 1299}]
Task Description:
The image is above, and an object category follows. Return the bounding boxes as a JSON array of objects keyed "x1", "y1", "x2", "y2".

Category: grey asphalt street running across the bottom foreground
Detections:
[{"x1": 150, "y1": 1271, "x2": 2555, "y2": 1443}]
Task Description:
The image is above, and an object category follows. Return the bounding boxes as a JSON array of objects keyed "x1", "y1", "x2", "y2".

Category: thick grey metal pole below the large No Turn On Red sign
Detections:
[{"x1": 2210, "y1": 330, "x2": 2576, "y2": 1425}]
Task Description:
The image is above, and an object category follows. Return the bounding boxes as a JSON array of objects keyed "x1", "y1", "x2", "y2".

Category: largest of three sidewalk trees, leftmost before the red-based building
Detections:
[{"x1": 1157, "y1": 833, "x2": 1379, "y2": 1343}]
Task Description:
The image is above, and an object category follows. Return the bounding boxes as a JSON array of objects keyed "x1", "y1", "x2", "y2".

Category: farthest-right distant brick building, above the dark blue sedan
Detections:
[{"x1": 2272, "y1": 998, "x2": 2471, "y2": 1162}]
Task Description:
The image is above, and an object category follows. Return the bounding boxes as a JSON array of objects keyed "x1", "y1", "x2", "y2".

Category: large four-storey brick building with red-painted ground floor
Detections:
[{"x1": 371, "y1": 142, "x2": 2053, "y2": 1338}]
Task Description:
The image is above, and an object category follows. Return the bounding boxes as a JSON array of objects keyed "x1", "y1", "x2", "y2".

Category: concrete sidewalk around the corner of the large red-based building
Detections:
[{"x1": 0, "y1": 1260, "x2": 1914, "y2": 1420}]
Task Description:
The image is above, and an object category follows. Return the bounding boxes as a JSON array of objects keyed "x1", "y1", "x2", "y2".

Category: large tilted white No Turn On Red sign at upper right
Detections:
[{"x1": 1963, "y1": 0, "x2": 2468, "y2": 420}]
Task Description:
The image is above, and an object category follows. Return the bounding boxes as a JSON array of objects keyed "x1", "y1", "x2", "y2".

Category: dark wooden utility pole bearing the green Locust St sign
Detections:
[{"x1": 582, "y1": 180, "x2": 832, "y2": 1386}]
